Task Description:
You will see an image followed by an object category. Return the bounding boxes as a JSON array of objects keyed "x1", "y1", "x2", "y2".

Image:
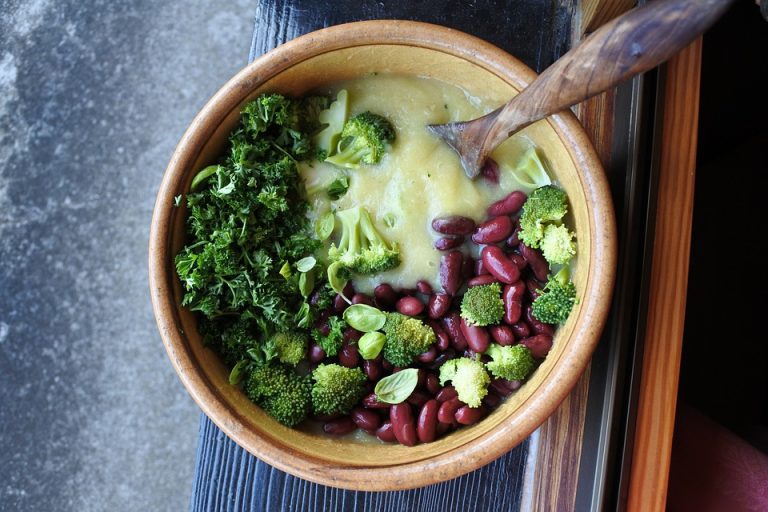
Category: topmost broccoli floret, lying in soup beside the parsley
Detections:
[{"x1": 326, "y1": 112, "x2": 395, "y2": 169}]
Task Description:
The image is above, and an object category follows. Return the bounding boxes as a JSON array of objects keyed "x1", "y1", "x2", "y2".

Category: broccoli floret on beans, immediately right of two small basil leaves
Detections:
[{"x1": 382, "y1": 313, "x2": 437, "y2": 367}]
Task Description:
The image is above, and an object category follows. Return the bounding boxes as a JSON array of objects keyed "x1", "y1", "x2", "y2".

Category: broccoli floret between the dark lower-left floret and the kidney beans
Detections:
[{"x1": 312, "y1": 364, "x2": 367, "y2": 414}]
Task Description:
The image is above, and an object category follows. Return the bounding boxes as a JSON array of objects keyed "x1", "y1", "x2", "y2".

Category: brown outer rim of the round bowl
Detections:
[{"x1": 149, "y1": 20, "x2": 616, "y2": 491}]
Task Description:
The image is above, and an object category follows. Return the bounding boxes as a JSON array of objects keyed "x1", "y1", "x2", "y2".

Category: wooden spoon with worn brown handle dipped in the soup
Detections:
[{"x1": 428, "y1": 0, "x2": 733, "y2": 179}]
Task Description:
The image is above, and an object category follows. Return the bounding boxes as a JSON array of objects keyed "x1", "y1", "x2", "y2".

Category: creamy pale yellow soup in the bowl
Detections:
[{"x1": 301, "y1": 74, "x2": 532, "y2": 293}]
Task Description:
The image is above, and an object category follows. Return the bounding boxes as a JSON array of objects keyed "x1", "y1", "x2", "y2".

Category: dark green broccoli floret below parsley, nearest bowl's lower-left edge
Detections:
[{"x1": 245, "y1": 363, "x2": 312, "y2": 427}]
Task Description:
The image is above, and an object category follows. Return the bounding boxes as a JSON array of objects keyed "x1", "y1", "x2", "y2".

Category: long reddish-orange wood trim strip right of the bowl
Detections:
[{"x1": 627, "y1": 38, "x2": 702, "y2": 512}]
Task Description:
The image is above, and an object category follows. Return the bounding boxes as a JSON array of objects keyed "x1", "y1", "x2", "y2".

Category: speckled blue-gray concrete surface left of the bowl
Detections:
[{"x1": 0, "y1": 0, "x2": 256, "y2": 512}]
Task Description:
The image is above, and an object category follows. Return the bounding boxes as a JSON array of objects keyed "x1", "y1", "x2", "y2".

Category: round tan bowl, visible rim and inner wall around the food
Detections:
[{"x1": 149, "y1": 21, "x2": 616, "y2": 491}]
